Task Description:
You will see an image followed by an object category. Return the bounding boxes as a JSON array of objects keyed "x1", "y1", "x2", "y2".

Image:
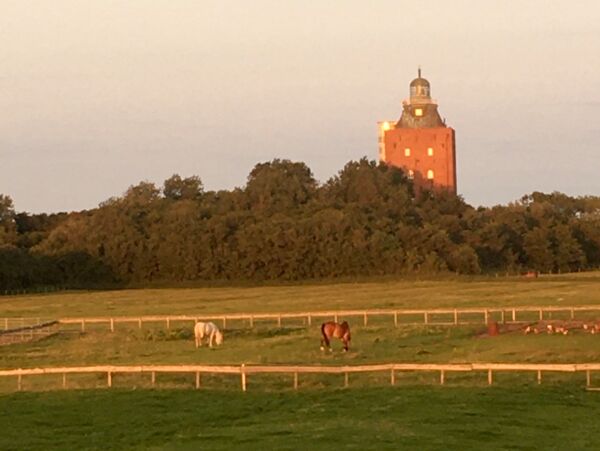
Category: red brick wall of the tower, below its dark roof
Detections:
[{"x1": 384, "y1": 127, "x2": 456, "y2": 193}]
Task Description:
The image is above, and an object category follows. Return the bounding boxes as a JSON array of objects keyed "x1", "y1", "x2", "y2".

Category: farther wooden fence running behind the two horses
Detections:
[{"x1": 54, "y1": 304, "x2": 600, "y2": 332}]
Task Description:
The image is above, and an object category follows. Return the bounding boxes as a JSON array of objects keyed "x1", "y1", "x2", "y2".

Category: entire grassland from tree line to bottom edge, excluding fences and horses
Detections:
[{"x1": 0, "y1": 273, "x2": 600, "y2": 450}]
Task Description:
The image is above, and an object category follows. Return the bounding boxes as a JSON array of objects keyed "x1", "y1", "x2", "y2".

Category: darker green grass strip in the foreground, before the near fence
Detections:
[{"x1": 0, "y1": 387, "x2": 600, "y2": 451}]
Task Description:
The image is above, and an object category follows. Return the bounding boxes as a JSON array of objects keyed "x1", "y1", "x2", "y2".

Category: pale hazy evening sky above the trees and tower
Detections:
[{"x1": 0, "y1": 0, "x2": 600, "y2": 212}]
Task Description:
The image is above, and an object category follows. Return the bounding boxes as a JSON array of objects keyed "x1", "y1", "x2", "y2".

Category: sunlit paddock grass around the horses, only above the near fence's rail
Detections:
[{"x1": 0, "y1": 325, "x2": 600, "y2": 374}]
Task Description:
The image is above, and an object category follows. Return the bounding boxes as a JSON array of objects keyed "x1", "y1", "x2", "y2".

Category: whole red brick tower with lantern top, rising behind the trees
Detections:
[{"x1": 377, "y1": 69, "x2": 456, "y2": 194}]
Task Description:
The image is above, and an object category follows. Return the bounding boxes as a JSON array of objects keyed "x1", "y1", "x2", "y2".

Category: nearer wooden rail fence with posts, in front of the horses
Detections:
[{"x1": 0, "y1": 363, "x2": 600, "y2": 391}]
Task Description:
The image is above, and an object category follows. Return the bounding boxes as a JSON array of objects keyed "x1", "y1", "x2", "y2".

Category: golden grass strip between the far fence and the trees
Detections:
[{"x1": 0, "y1": 272, "x2": 600, "y2": 318}]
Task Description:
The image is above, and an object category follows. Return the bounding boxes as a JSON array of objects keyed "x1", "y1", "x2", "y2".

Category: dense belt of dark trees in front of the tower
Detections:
[{"x1": 0, "y1": 159, "x2": 600, "y2": 289}]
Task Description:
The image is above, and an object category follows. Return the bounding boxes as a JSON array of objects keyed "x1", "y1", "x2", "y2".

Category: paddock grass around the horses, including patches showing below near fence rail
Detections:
[{"x1": 0, "y1": 323, "x2": 600, "y2": 392}]
